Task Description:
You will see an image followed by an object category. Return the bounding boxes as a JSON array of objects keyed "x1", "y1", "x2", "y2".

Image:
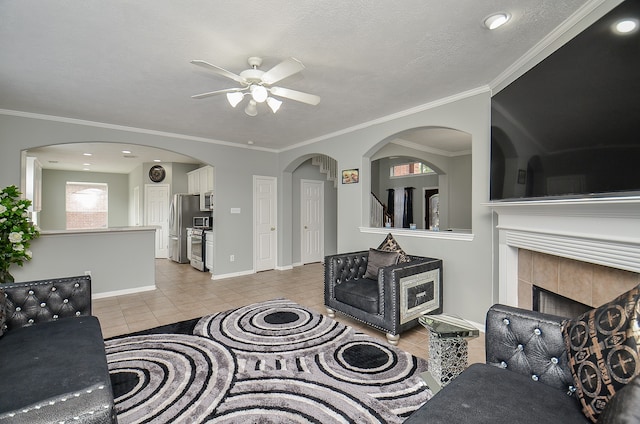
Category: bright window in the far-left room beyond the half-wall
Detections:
[{"x1": 65, "y1": 182, "x2": 109, "y2": 230}]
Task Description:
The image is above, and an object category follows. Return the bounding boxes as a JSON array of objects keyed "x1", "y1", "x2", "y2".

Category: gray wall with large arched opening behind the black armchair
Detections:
[{"x1": 280, "y1": 90, "x2": 498, "y2": 322}]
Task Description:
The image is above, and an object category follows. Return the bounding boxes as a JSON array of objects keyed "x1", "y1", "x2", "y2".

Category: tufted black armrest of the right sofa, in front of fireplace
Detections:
[{"x1": 485, "y1": 305, "x2": 574, "y2": 393}]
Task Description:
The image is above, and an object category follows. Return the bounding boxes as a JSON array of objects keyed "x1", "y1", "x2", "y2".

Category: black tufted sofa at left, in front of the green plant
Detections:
[{"x1": 0, "y1": 276, "x2": 117, "y2": 424}]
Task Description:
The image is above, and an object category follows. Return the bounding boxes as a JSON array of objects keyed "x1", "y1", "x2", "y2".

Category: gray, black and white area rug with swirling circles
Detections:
[{"x1": 105, "y1": 299, "x2": 432, "y2": 424}]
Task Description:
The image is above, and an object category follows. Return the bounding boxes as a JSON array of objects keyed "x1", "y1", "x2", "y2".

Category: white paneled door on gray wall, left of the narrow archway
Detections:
[{"x1": 253, "y1": 175, "x2": 278, "y2": 272}]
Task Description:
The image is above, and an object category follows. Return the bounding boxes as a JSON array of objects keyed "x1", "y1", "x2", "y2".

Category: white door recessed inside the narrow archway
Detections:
[{"x1": 300, "y1": 180, "x2": 324, "y2": 265}]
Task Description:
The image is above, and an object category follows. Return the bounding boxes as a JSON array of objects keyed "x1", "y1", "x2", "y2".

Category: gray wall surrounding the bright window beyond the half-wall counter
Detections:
[{"x1": 40, "y1": 169, "x2": 129, "y2": 230}]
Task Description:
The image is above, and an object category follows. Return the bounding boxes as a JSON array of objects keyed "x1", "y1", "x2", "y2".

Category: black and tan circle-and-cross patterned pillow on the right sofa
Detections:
[{"x1": 562, "y1": 286, "x2": 640, "y2": 423}]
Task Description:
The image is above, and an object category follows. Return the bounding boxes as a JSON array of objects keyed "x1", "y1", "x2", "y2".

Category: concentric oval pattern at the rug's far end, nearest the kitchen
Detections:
[{"x1": 193, "y1": 300, "x2": 350, "y2": 354}]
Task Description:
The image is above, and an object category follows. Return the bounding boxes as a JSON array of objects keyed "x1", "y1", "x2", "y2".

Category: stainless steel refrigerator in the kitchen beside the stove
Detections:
[{"x1": 169, "y1": 194, "x2": 200, "y2": 264}]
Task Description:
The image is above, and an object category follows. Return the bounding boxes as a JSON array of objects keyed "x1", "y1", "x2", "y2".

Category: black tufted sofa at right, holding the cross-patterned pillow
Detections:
[{"x1": 405, "y1": 303, "x2": 640, "y2": 424}]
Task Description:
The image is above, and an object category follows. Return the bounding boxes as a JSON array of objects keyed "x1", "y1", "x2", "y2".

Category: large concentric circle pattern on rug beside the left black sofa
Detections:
[{"x1": 105, "y1": 334, "x2": 235, "y2": 424}]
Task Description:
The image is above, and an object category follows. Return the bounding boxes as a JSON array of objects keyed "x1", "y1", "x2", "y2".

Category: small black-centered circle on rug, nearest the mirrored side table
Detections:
[{"x1": 316, "y1": 334, "x2": 418, "y2": 386}]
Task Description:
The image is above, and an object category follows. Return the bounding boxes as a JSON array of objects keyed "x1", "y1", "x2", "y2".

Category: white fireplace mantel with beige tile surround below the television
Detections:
[{"x1": 486, "y1": 197, "x2": 640, "y2": 309}]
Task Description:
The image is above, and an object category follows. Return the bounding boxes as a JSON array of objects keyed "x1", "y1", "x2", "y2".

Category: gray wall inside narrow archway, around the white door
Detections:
[{"x1": 291, "y1": 159, "x2": 338, "y2": 264}]
